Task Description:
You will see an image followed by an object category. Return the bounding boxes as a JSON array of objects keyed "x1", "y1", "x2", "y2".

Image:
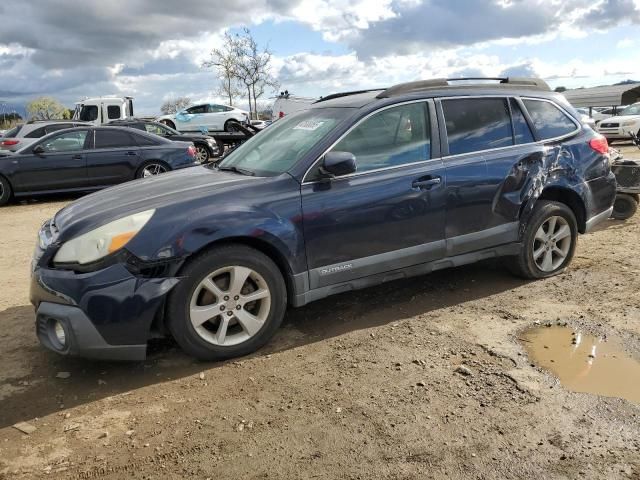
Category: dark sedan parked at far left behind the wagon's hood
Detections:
[{"x1": 0, "y1": 127, "x2": 199, "y2": 205}]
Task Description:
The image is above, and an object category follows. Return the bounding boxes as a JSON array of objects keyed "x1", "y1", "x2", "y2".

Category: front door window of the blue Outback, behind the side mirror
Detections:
[{"x1": 333, "y1": 103, "x2": 431, "y2": 172}]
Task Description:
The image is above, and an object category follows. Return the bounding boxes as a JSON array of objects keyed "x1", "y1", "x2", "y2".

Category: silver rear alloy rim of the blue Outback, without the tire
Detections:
[{"x1": 533, "y1": 215, "x2": 573, "y2": 272}]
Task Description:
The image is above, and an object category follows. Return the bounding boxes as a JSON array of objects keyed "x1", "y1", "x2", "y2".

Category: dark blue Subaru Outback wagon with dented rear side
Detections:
[{"x1": 31, "y1": 79, "x2": 615, "y2": 360}]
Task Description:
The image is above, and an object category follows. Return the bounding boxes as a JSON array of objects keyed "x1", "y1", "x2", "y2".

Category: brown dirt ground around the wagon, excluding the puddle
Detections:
[{"x1": 0, "y1": 144, "x2": 640, "y2": 480}]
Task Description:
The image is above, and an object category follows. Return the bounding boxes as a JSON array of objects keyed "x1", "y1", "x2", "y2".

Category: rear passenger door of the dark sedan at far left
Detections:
[{"x1": 87, "y1": 128, "x2": 140, "y2": 186}]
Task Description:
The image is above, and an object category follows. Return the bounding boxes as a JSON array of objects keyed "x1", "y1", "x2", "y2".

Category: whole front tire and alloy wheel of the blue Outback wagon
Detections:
[{"x1": 166, "y1": 245, "x2": 287, "y2": 361}]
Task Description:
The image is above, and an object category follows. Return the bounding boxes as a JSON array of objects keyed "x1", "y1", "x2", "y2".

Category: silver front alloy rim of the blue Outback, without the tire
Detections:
[{"x1": 189, "y1": 266, "x2": 271, "y2": 346}]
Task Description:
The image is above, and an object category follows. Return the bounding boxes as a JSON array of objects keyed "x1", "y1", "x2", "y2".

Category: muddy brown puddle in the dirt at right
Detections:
[{"x1": 520, "y1": 327, "x2": 640, "y2": 403}]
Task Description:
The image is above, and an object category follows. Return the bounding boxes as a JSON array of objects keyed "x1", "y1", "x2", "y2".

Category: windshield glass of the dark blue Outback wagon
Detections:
[{"x1": 220, "y1": 108, "x2": 353, "y2": 176}]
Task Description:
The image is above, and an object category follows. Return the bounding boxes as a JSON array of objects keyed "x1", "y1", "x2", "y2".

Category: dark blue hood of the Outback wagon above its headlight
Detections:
[{"x1": 54, "y1": 167, "x2": 264, "y2": 241}]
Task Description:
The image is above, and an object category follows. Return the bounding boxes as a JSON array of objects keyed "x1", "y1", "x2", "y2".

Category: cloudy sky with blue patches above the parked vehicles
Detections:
[{"x1": 0, "y1": 0, "x2": 640, "y2": 114}]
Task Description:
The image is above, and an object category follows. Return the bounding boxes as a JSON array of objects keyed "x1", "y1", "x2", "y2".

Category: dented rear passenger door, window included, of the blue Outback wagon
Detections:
[{"x1": 440, "y1": 96, "x2": 544, "y2": 256}]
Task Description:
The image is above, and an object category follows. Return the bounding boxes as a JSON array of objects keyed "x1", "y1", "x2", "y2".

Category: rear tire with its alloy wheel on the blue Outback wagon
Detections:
[{"x1": 507, "y1": 200, "x2": 578, "y2": 279}]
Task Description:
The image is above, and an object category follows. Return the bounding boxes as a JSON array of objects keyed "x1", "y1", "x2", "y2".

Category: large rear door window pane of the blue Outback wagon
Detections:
[{"x1": 442, "y1": 98, "x2": 513, "y2": 155}]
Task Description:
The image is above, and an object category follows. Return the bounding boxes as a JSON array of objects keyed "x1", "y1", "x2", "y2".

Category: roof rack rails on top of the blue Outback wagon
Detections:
[{"x1": 376, "y1": 77, "x2": 551, "y2": 98}]
